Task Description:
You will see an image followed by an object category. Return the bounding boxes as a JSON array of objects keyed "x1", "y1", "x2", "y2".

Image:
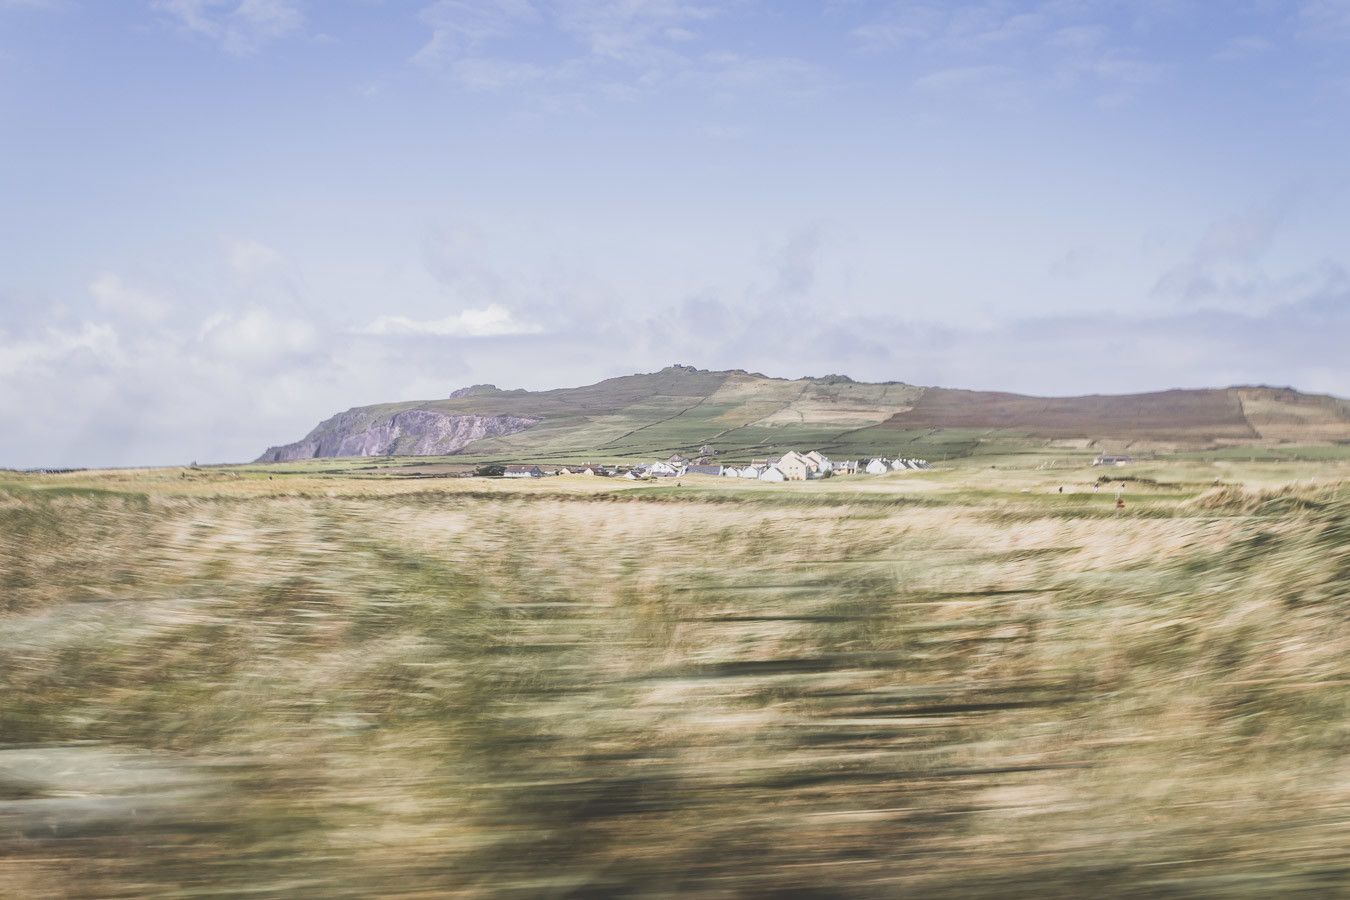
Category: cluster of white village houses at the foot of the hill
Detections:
[{"x1": 501, "y1": 445, "x2": 929, "y2": 483}]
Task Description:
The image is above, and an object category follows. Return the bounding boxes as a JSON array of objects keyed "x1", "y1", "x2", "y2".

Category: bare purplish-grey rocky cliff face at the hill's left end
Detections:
[{"x1": 258, "y1": 409, "x2": 539, "y2": 463}]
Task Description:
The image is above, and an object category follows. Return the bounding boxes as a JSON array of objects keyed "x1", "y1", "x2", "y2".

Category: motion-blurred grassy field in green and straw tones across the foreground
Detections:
[{"x1": 0, "y1": 451, "x2": 1350, "y2": 899}]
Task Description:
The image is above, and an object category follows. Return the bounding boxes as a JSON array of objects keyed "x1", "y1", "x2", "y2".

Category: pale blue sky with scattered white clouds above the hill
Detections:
[{"x1": 0, "y1": 0, "x2": 1350, "y2": 467}]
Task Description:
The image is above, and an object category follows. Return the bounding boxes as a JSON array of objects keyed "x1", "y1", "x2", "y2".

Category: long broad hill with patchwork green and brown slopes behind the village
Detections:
[{"x1": 259, "y1": 366, "x2": 1350, "y2": 463}]
